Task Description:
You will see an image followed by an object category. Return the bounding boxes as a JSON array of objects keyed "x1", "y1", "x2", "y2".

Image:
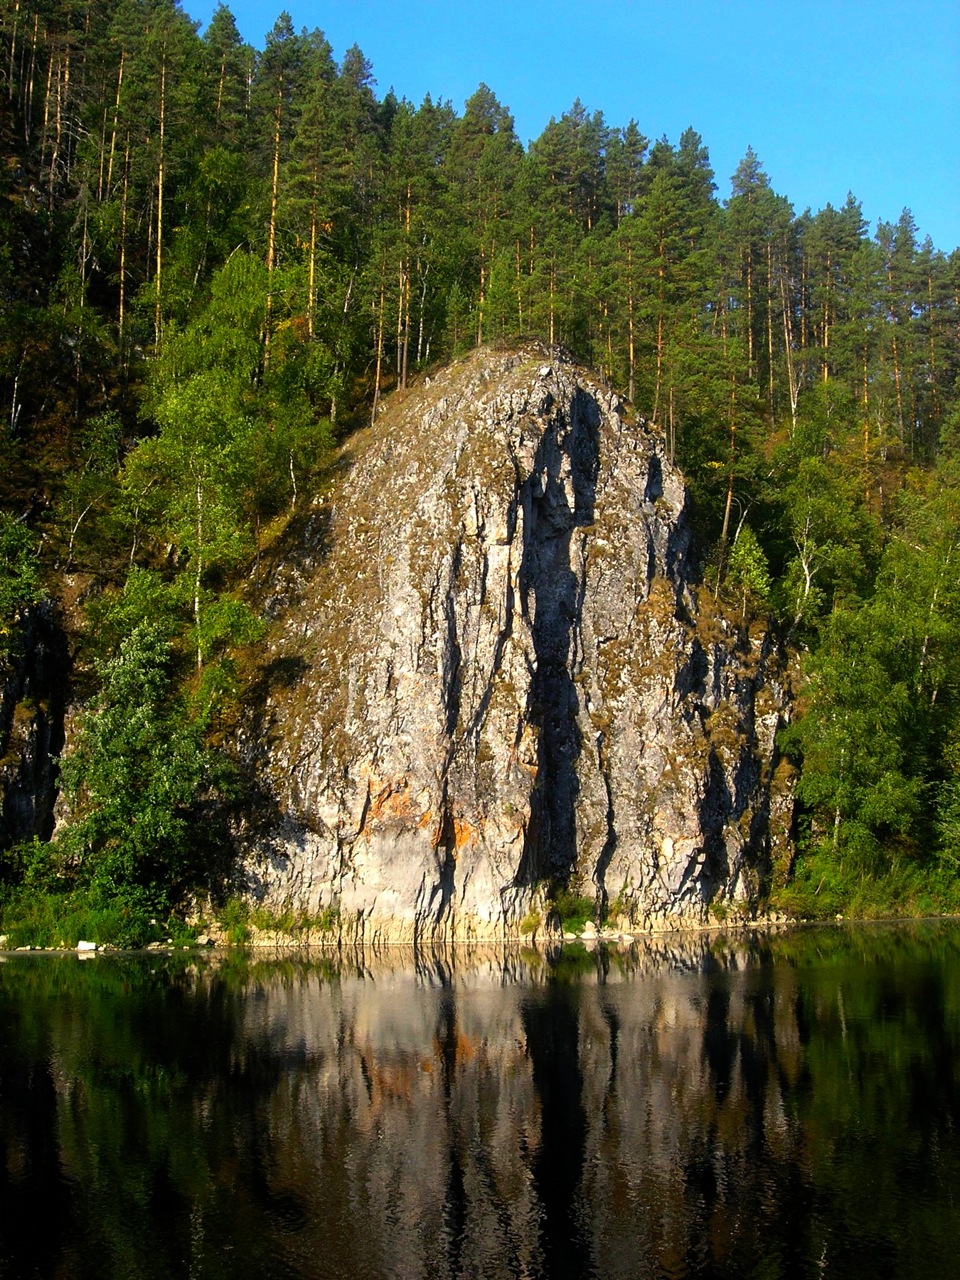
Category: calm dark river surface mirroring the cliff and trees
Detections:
[{"x1": 0, "y1": 923, "x2": 960, "y2": 1280}]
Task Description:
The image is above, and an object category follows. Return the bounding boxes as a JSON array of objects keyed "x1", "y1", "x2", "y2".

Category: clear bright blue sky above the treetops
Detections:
[{"x1": 192, "y1": 0, "x2": 960, "y2": 251}]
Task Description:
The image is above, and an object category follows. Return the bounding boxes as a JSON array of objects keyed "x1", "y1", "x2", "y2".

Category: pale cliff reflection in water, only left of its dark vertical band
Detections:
[{"x1": 235, "y1": 974, "x2": 541, "y2": 1276}]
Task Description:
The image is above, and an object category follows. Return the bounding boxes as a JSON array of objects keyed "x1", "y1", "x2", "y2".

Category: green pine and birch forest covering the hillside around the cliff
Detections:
[{"x1": 0, "y1": 0, "x2": 960, "y2": 933}]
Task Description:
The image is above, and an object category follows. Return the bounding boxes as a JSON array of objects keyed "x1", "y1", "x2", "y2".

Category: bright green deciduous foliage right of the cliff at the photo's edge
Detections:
[{"x1": 785, "y1": 467, "x2": 960, "y2": 876}]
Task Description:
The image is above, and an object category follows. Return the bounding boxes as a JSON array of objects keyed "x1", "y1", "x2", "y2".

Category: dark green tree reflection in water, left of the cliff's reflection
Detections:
[{"x1": 0, "y1": 960, "x2": 296, "y2": 1277}]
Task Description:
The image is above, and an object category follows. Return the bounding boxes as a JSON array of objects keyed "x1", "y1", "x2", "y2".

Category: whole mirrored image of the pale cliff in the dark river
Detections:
[{"x1": 239, "y1": 947, "x2": 791, "y2": 1276}]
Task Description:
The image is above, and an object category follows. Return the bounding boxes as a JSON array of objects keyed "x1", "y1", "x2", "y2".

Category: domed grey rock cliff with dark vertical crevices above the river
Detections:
[{"x1": 242, "y1": 347, "x2": 788, "y2": 941}]
